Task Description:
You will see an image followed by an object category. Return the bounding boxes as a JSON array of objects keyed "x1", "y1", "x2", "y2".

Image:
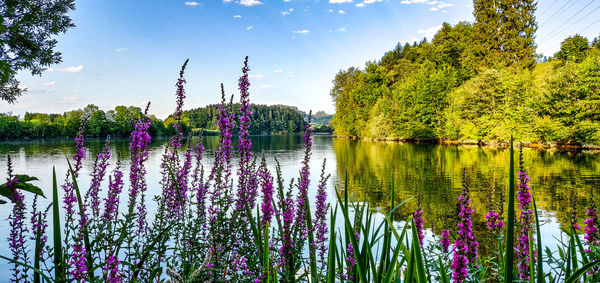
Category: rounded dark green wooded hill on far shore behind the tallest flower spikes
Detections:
[{"x1": 179, "y1": 104, "x2": 306, "y2": 135}]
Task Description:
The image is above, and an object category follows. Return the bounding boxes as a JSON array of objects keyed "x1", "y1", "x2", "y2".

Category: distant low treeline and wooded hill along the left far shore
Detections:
[{"x1": 0, "y1": 104, "x2": 310, "y2": 139}]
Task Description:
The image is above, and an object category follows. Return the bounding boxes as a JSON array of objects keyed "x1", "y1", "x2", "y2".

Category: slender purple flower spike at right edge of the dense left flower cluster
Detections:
[{"x1": 313, "y1": 160, "x2": 330, "y2": 269}]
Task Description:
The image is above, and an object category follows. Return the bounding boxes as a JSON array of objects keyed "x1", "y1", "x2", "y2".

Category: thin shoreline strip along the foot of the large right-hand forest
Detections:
[{"x1": 333, "y1": 135, "x2": 600, "y2": 152}]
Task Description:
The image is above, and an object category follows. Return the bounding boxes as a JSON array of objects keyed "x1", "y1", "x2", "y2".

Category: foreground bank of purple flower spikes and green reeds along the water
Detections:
[{"x1": 0, "y1": 58, "x2": 600, "y2": 283}]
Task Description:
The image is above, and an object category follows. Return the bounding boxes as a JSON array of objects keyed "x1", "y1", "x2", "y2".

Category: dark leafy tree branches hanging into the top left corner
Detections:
[{"x1": 0, "y1": 0, "x2": 75, "y2": 103}]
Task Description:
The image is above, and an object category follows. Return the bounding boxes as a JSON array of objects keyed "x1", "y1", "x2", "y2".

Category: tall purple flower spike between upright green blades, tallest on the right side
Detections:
[{"x1": 517, "y1": 145, "x2": 535, "y2": 280}]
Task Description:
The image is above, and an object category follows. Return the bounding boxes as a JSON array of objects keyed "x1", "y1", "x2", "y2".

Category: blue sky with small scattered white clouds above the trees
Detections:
[{"x1": 0, "y1": 0, "x2": 600, "y2": 118}]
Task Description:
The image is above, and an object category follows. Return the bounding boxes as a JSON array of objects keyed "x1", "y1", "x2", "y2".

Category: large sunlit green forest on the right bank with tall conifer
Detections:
[{"x1": 331, "y1": 0, "x2": 600, "y2": 143}]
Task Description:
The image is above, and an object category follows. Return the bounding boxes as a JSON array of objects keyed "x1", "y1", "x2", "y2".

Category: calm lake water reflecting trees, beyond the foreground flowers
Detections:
[{"x1": 0, "y1": 135, "x2": 600, "y2": 278}]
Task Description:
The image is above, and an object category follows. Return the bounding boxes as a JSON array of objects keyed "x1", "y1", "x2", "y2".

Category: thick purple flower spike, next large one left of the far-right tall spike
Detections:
[{"x1": 451, "y1": 170, "x2": 479, "y2": 283}]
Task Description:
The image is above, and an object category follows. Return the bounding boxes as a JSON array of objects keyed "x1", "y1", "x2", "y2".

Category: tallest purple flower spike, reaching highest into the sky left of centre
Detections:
[{"x1": 236, "y1": 56, "x2": 256, "y2": 213}]
